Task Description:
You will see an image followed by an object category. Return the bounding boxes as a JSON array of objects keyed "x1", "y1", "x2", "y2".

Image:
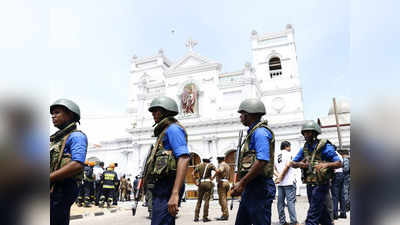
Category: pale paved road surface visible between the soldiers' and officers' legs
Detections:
[{"x1": 70, "y1": 197, "x2": 350, "y2": 225}]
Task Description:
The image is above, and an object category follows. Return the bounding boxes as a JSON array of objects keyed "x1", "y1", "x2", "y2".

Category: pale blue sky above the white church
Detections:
[{"x1": 0, "y1": 0, "x2": 398, "y2": 119}]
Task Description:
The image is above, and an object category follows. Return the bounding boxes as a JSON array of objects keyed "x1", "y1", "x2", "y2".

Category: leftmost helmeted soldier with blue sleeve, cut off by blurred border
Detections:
[{"x1": 50, "y1": 99, "x2": 87, "y2": 225}]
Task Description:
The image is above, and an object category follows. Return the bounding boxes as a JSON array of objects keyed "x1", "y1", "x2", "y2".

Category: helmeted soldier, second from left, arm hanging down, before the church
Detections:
[{"x1": 144, "y1": 96, "x2": 189, "y2": 225}]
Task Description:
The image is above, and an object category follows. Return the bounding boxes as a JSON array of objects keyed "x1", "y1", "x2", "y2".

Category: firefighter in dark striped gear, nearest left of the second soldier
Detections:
[{"x1": 99, "y1": 163, "x2": 118, "y2": 208}]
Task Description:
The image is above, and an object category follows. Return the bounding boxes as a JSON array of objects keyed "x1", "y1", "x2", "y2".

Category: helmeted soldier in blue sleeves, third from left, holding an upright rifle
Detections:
[{"x1": 232, "y1": 99, "x2": 276, "y2": 225}]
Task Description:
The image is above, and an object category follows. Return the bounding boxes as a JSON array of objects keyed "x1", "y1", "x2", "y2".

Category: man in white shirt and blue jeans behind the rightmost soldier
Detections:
[{"x1": 274, "y1": 141, "x2": 297, "y2": 225}]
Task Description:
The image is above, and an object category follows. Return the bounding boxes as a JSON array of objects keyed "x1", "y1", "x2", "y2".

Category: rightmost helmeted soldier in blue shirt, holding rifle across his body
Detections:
[{"x1": 290, "y1": 120, "x2": 342, "y2": 225}]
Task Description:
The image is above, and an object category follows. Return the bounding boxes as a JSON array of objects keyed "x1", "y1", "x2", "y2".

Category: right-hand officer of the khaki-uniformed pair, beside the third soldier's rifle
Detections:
[{"x1": 213, "y1": 155, "x2": 230, "y2": 220}]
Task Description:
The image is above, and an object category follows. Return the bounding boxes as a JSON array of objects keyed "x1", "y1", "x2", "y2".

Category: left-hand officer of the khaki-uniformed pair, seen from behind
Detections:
[{"x1": 192, "y1": 158, "x2": 216, "y2": 222}]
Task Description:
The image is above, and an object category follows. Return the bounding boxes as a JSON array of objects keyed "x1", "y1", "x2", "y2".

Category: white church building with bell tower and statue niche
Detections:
[{"x1": 87, "y1": 25, "x2": 350, "y2": 197}]
